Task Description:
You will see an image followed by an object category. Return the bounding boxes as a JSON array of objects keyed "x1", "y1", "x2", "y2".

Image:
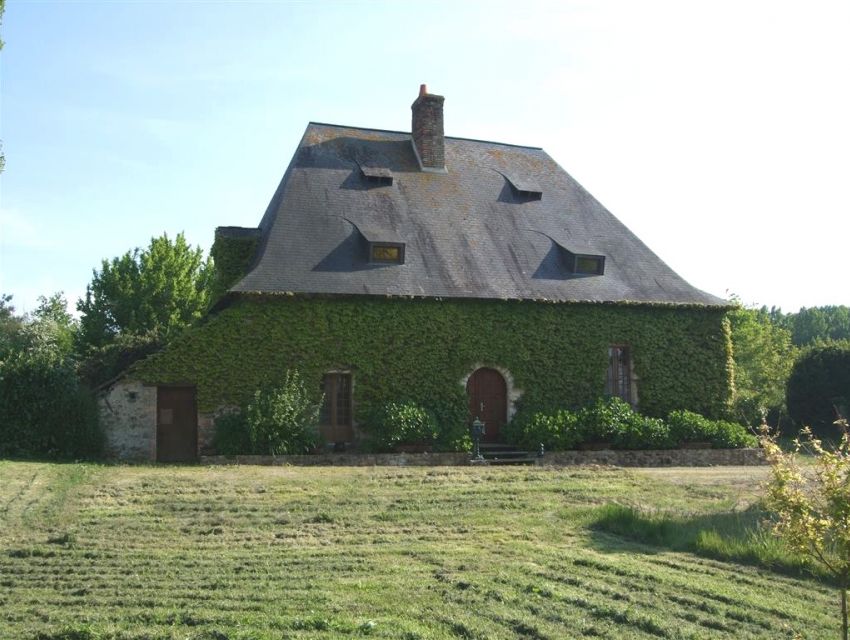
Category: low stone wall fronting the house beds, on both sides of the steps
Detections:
[{"x1": 201, "y1": 449, "x2": 765, "y2": 467}]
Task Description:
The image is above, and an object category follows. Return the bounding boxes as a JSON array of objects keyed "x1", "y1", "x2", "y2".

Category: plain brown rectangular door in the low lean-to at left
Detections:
[{"x1": 156, "y1": 387, "x2": 198, "y2": 462}]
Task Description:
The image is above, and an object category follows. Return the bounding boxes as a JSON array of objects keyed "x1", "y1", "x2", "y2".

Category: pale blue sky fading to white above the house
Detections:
[{"x1": 0, "y1": 0, "x2": 850, "y2": 311}]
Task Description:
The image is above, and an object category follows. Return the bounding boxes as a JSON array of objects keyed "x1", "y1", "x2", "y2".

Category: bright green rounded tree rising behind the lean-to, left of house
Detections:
[{"x1": 77, "y1": 233, "x2": 212, "y2": 350}]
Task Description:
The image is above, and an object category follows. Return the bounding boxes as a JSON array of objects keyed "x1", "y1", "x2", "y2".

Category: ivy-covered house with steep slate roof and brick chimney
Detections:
[{"x1": 102, "y1": 85, "x2": 732, "y2": 460}]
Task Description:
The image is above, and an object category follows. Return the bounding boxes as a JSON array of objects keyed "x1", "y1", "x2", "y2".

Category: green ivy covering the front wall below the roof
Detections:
[{"x1": 131, "y1": 295, "x2": 732, "y2": 430}]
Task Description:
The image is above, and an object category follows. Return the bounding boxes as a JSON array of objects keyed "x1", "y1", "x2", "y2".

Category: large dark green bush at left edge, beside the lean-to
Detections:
[{"x1": 0, "y1": 350, "x2": 103, "y2": 458}]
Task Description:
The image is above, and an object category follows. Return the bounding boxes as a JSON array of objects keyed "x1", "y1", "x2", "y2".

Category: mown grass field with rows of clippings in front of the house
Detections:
[{"x1": 0, "y1": 462, "x2": 840, "y2": 640}]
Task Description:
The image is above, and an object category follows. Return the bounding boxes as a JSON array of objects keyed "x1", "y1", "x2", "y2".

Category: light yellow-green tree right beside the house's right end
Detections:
[{"x1": 729, "y1": 304, "x2": 796, "y2": 424}]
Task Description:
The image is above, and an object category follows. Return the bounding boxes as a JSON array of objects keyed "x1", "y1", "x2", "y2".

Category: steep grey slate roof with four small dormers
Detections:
[{"x1": 231, "y1": 123, "x2": 728, "y2": 306}]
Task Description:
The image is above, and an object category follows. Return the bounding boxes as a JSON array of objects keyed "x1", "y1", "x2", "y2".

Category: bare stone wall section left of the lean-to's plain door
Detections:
[{"x1": 98, "y1": 380, "x2": 156, "y2": 461}]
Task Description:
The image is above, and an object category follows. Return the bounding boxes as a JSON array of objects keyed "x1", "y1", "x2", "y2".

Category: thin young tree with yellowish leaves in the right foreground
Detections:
[{"x1": 762, "y1": 417, "x2": 850, "y2": 640}]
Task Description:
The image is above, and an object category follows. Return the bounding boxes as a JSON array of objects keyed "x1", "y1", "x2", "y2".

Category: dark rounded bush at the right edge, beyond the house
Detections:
[{"x1": 787, "y1": 341, "x2": 850, "y2": 433}]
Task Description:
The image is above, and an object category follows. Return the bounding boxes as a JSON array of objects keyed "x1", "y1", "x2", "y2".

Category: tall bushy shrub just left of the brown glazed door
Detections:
[{"x1": 248, "y1": 371, "x2": 320, "y2": 455}]
